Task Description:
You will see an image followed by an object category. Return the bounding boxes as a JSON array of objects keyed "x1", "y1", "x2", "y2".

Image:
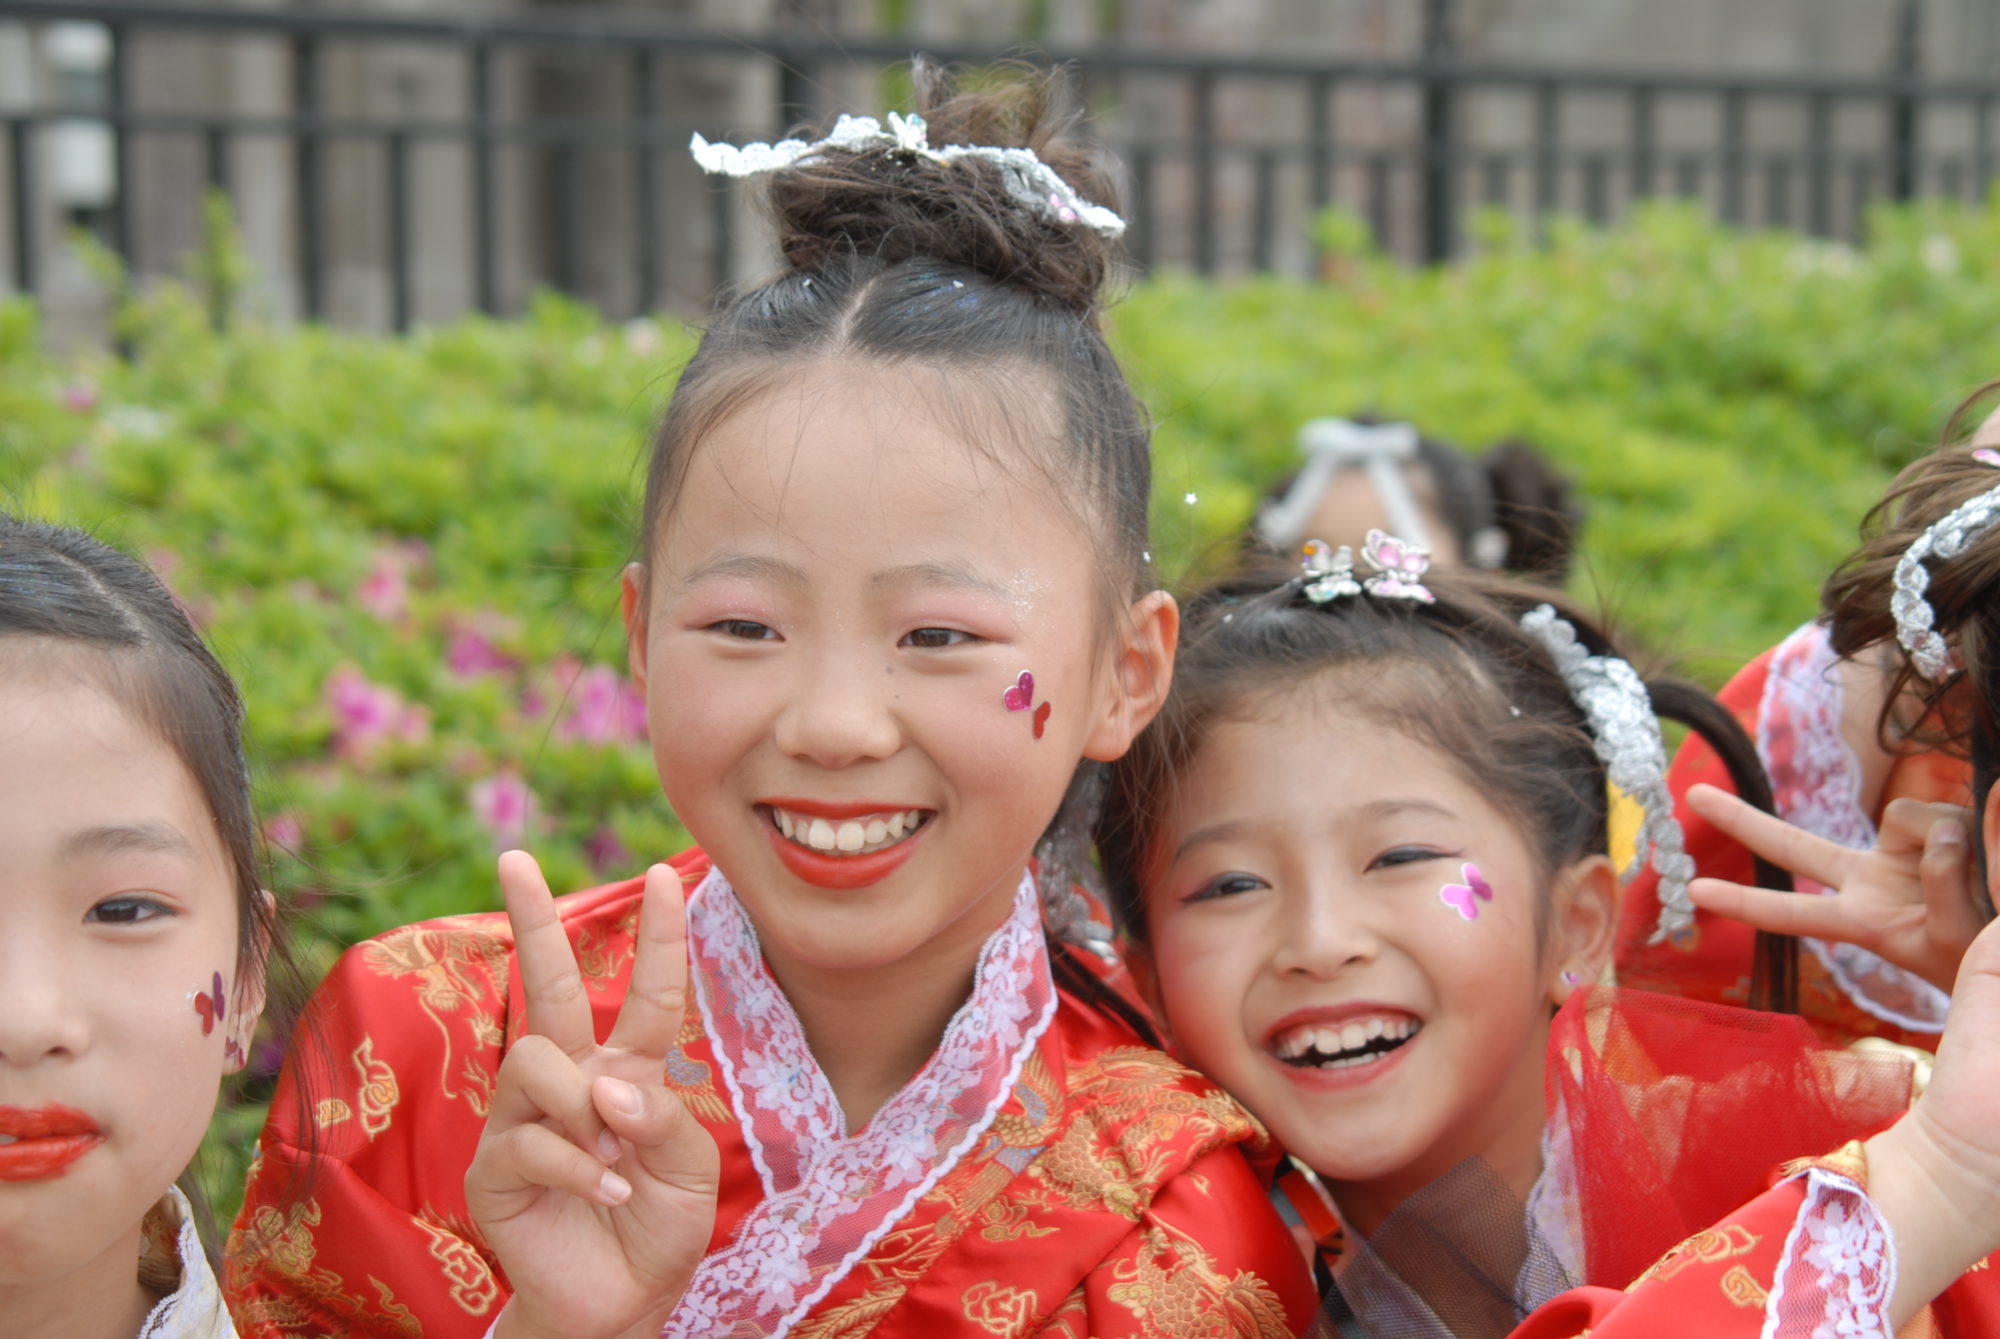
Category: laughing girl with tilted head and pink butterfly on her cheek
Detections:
[{"x1": 1102, "y1": 534, "x2": 2000, "y2": 1339}]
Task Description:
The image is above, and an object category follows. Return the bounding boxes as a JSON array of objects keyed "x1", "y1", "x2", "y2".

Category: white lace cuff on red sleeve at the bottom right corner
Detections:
[{"x1": 1760, "y1": 1167, "x2": 1896, "y2": 1339}]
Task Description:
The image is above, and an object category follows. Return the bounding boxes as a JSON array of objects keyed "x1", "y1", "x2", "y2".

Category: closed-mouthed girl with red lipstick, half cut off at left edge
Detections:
[{"x1": 0, "y1": 514, "x2": 284, "y2": 1339}]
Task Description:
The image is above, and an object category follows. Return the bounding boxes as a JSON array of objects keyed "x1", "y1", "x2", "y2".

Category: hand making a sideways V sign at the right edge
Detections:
[{"x1": 1688, "y1": 785, "x2": 1986, "y2": 991}]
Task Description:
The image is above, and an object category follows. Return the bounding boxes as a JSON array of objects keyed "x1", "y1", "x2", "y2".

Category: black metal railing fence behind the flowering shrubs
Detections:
[{"x1": 0, "y1": 0, "x2": 2000, "y2": 328}]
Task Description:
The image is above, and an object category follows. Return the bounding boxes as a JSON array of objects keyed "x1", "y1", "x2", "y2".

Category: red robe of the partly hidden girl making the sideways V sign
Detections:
[{"x1": 1618, "y1": 624, "x2": 1972, "y2": 1051}]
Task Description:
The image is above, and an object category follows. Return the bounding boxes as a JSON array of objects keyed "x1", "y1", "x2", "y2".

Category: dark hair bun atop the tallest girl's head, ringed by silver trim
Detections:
[{"x1": 770, "y1": 58, "x2": 1118, "y2": 316}]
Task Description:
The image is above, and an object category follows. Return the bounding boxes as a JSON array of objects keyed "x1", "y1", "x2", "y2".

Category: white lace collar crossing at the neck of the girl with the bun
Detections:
[{"x1": 664, "y1": 869, "x2": 1056, "y2": 1339}]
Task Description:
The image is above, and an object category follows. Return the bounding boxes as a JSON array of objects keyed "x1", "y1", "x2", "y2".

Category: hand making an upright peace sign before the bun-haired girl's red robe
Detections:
[{"x1": 466, "y1": 851, "x2": 718, "y2": 1339}]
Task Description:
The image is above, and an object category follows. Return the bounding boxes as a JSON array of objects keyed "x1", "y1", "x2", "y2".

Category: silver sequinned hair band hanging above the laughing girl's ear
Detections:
[{"x1": 1520, "y1": 604, "x2": 1694, "y2": 943}]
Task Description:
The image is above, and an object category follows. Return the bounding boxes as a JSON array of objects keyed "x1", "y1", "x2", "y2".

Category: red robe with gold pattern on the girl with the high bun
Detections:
[{"x1": 228, "y1": 851, "x2": 1314, "y2": 1339}]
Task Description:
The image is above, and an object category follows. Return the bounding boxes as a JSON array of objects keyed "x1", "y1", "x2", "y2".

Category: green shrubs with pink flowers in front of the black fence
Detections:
[{"x1": 11, "y1": 193, "x2": 2000, "y2": 1207}]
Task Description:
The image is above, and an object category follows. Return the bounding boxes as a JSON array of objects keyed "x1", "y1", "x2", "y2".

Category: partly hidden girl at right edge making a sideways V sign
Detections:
[{"x1": 1618, "y1": 386, "x2": 2000, "y2": 1049}]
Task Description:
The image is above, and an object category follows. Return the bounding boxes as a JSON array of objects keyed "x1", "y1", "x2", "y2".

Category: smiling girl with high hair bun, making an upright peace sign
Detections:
[{"x1": 230, "y1": 70, "x2": 1314, "y2": 1339}]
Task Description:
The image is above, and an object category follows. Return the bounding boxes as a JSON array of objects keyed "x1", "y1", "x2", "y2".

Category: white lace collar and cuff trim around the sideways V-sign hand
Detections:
[{"x1": 1756, "y1": 624, "x2": 1952, "y2": 1033}]
